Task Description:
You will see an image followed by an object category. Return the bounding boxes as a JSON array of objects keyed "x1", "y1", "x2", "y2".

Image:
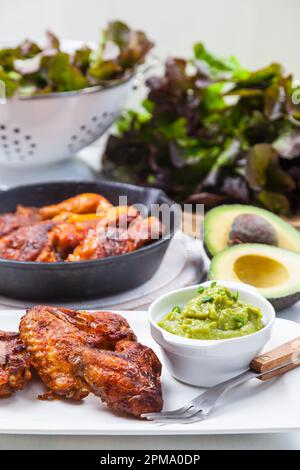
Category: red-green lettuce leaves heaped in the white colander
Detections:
[{"x1": 0, "y1": 21, "x2": 153, "y2": 97}]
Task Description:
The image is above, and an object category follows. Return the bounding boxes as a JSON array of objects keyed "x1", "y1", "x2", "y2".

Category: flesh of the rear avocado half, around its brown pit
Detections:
[{"x1": 204, "y1": 204, "x2": 300, "y2": 258}]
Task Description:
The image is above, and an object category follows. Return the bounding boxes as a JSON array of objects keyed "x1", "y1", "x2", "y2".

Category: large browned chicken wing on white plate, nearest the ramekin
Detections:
[{"x1": 20, "y1": 306, "x2": 163, "y2": 416}]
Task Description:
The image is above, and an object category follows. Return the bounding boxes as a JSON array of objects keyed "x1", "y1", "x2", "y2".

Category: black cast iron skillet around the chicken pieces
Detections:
[{"x1": 0, "y1": 181, "x2": 177, "y2": 302}]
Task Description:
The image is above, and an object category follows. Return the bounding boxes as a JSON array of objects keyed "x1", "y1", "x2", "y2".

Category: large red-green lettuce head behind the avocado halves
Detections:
[{"x1": 103, "y1": 43, "x2": 300, "y2": 215}]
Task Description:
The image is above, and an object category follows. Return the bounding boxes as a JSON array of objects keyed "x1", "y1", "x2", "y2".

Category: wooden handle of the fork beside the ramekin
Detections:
[{"x1": 250, "y1": 337, "x2": 300, "y2": 380}]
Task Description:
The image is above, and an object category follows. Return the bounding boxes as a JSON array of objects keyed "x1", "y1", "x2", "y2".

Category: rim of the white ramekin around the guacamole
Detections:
[{"x1": 148, "y1": 279, "x2": 276, "y2": 349}]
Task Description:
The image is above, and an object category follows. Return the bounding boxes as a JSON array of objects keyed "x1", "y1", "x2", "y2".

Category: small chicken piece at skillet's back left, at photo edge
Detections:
[{"x1": 0, "y1": 206, "x2": 41, "y2": 238}]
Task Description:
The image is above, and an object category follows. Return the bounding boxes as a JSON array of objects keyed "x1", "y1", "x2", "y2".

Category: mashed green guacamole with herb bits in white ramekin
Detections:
[{"x1": 158, "y1": 282, "x2": 264, "y2": 339}]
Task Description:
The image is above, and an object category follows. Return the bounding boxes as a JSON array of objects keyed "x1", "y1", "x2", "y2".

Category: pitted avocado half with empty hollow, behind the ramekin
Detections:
[{"x1": 209, "y1": 243, "x2": 300, "y2": 311}]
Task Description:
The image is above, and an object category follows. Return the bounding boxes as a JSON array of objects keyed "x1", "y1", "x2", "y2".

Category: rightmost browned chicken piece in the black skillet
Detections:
[{"x1": 67, "y1": 217, "x2": 163, "y2": 262}]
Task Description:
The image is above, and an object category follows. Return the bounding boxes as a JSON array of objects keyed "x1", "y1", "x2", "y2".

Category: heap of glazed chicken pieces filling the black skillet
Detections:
[{"x1": 0, "y1": 197, "x2": 162, "y2": 263}]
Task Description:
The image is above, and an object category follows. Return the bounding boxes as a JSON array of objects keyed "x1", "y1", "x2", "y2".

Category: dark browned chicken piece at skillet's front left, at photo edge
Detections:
[{"x1": 0, "y1": 222, "x2": 53, "y2": 261}]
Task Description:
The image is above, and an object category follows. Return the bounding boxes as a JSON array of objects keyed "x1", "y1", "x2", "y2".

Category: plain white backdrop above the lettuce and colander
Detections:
[{"x1": 0, "y1": 0, "x2": 300, "y2": 78}]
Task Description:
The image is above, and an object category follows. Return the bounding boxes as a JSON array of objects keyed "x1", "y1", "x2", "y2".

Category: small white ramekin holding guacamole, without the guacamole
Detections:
[{"x1": 149, "y1": 281, "x2": 275, "y2": 387}]
